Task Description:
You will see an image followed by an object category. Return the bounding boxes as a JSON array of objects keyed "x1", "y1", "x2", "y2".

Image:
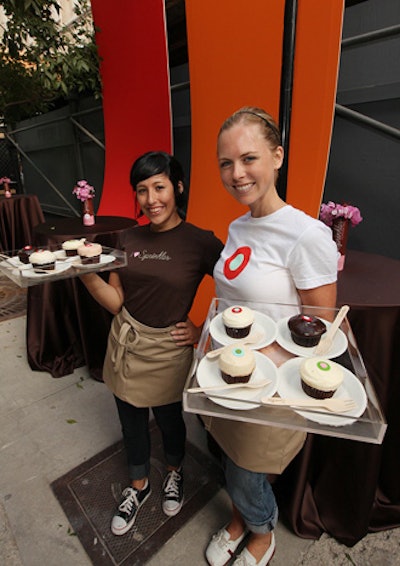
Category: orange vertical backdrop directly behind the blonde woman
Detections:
[{"x1": 186, "y1": 0, "x2": 344, "y2": 322}]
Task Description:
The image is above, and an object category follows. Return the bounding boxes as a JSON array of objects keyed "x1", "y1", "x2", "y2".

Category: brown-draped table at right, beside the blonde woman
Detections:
[{"x1": 275, "y1": 251, "x2": 400, "y2": 546}]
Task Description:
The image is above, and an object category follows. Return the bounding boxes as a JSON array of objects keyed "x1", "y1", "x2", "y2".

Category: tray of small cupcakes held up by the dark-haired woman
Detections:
[{"x1": 0, "y1": 238, "x2": 127, "y2": 287}]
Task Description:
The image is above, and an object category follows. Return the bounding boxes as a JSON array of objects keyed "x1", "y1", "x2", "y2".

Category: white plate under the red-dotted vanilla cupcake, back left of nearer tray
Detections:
[{"x1": 210, "y1": 311, "x2": 277, "y2": 350}]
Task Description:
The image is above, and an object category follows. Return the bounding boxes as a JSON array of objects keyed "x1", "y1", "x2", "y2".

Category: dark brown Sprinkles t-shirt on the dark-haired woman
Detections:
[{"x1": 118, "y1": 222, "x2": 223, "y2": 328}]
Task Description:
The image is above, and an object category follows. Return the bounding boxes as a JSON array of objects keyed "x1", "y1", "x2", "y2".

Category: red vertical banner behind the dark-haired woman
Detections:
[{"x1": 91, "y1": 0, "x2": 172, "y2": 217}]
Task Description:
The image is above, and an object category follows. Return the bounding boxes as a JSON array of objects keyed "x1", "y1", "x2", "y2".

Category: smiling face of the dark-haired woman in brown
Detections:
[{"x1": 136, "y1": 173, "x2": 183, "y2": 232}]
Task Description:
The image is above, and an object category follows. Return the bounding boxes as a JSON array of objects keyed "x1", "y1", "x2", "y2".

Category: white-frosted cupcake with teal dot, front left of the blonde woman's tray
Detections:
[{"x1": 218, "y1": 344, "x2": 256, "y2": 383}]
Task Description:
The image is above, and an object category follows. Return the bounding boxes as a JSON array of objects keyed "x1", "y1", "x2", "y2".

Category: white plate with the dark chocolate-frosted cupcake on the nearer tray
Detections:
[{"x1": 276, "y1": 314, "x2": 347, "y2": 358}]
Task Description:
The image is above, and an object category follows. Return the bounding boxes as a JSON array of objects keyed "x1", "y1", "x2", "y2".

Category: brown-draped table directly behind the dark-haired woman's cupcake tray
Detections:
[{"x1": 26, "y1": 216, "x2": 137, "y2": 381}]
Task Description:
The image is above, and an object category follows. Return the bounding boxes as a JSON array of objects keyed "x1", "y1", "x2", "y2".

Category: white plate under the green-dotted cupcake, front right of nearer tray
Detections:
[{"x1": 277, "y1": 358, "x2": 367, "y2": 426}]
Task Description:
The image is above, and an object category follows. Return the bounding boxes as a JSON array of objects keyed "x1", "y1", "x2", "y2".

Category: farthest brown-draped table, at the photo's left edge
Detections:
[{"x1": 0, "y1": 195, "x2": 44, "y2": 252}]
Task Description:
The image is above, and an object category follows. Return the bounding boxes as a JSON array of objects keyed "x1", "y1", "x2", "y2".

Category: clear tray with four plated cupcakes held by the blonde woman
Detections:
[{"x1": 183, "y1": 298, "x2": 387, "y2": 444}]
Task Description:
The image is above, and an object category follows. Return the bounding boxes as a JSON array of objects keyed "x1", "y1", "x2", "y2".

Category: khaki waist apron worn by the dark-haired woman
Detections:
[{"x1": 103, "y1": 307, "x2": 193, "y2": 407}]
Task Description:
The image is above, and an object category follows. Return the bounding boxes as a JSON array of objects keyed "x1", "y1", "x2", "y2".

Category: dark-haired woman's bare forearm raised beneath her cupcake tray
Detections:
[{"x1": 80, "y1": 271, "x2": 124, "y2": 314}]
